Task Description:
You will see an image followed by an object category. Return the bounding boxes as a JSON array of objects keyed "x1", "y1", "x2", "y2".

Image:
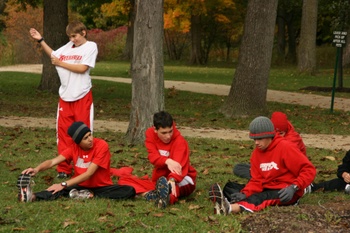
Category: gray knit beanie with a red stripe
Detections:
[{"x1": 249, "y1": 116, "x2": 275, "y2": 139}]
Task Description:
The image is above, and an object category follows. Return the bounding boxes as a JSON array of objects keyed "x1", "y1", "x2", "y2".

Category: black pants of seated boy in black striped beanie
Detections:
[{"x1": 34, "y1": 185, "x2": 136, "y2": 201}]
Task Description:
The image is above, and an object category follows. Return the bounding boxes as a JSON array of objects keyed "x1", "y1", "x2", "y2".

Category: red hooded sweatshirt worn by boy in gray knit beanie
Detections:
[{"x1": 242, "y1": 136, "x2": 316, "y2": 197}]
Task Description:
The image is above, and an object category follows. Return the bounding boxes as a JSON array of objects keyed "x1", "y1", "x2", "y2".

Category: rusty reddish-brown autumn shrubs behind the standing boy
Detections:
[{"x1": 0, "y1": 1, "x2": 127, "y2": 65}]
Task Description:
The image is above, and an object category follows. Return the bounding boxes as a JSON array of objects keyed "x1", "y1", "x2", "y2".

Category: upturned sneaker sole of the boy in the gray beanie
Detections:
[{"x1": 209, "y1": 183, "x2": 230, "y2": 215}]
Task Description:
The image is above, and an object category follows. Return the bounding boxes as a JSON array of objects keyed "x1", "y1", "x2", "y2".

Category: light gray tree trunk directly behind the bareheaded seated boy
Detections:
[{"x1": 126, "y1": 0, "x2": 164, "y2": 144}]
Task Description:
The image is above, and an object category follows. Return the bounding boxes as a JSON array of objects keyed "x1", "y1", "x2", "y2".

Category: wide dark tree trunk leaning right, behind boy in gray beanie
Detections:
[{"x1": 221, "y1": 0, "x2": 278, "y2": 117}]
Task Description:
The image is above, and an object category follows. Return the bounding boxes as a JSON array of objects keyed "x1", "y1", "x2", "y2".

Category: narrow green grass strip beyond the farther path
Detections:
[{"x1": 91, "y1": 62, "x2": 350, "y2": 98}]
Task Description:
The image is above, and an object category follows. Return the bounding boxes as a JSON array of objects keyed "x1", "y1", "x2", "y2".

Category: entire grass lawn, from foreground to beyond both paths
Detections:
[{"x1": 0, "y1": 63, "x2": 350, "y2": 232}]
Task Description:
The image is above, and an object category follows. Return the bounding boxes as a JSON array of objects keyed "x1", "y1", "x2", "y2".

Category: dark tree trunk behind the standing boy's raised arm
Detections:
[{"x1": 39, "y1": 0, "x2": 68, "y2": 93}]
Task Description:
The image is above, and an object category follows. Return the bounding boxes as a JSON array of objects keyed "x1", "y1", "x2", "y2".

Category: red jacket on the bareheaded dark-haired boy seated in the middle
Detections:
[{"x1": 145, "y1": 123, "x2": 197, "y2": 184}]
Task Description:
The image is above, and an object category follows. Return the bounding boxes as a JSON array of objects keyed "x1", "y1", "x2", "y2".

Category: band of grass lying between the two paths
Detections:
[{"x1": 0, "y1": 72, "x2": 350, "y2": 135}]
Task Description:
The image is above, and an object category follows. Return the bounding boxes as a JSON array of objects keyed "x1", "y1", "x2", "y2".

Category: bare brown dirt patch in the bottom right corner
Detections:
[{"x1": 241, "y1": 200, "x2": 350, "y2": 233}]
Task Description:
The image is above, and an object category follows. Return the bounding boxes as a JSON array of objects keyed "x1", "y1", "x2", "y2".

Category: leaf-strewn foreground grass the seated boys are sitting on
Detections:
[{"x1": 0, "y1": 127, "x2": 350, "y2": 232}]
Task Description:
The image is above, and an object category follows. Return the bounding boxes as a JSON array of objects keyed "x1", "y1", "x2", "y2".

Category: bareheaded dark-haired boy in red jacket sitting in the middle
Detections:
[{"x1": 145, "y1": 111, "x2": 197, "y2": 208}]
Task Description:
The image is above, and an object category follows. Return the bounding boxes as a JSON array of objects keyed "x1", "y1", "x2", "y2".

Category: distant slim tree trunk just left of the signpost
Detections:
[{"x1": 298, "y1": 0, "x2": 318, "y2": 75}]
